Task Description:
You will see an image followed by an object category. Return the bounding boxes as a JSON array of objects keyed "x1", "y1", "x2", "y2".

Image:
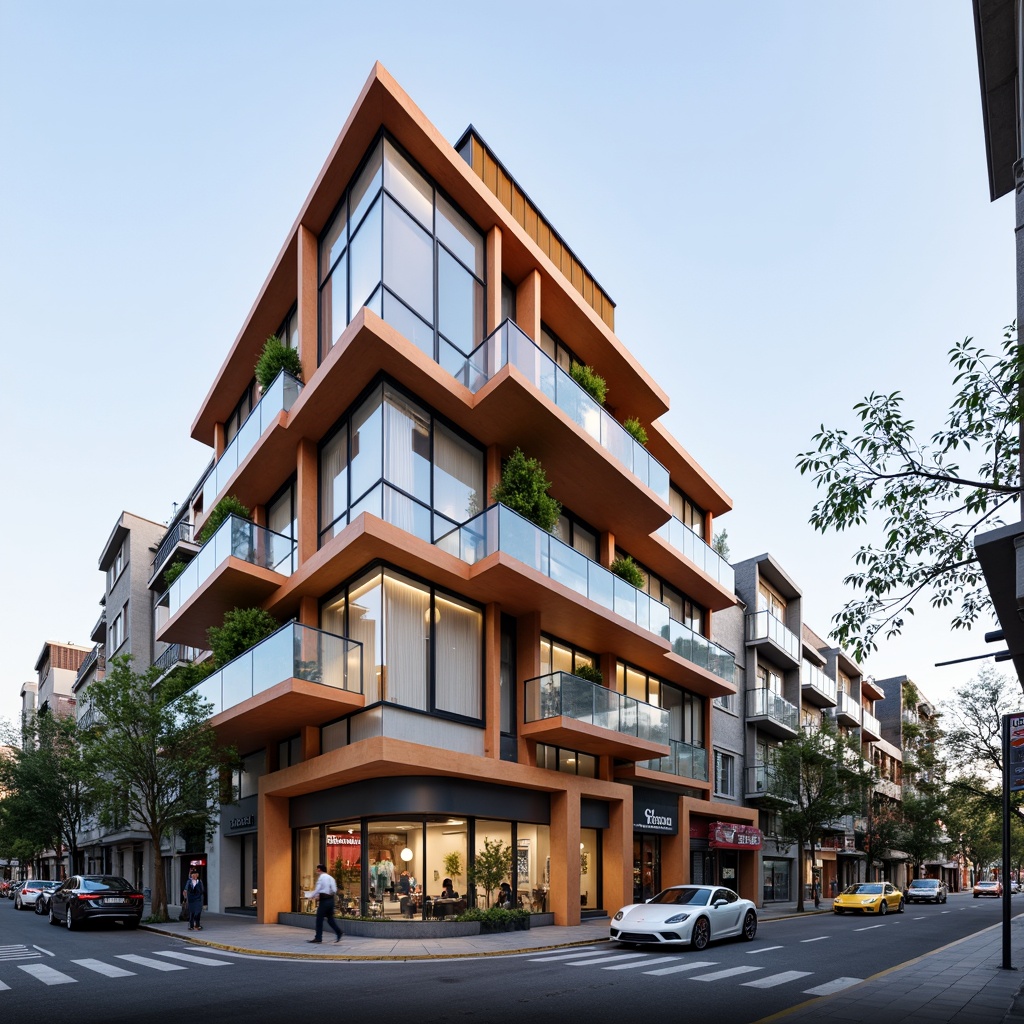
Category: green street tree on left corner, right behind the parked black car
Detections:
[{"x1": 79, "y1": 657, "x2": 238, "y2": 921}]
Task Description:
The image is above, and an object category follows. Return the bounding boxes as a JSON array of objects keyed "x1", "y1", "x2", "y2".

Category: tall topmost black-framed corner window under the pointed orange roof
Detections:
[{"x1": 319, "y1": 138, "x2": 484, "y2": 365}]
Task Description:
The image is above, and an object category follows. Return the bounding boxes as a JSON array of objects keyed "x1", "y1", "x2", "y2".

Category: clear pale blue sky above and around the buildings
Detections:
[{"x1": 0, "y1": 0, "x2": 1016, "y2": 718}]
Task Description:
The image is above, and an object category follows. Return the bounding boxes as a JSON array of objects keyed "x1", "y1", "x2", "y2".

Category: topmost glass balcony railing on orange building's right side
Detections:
[{"x1": 439, "y1": 321, "x2": 669, "y2": 504}]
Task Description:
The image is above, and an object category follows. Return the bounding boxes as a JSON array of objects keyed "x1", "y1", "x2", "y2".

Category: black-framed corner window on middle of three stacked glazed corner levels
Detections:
[{"x1": 319, "y1": 384, "x2": 484, "y2": 546}]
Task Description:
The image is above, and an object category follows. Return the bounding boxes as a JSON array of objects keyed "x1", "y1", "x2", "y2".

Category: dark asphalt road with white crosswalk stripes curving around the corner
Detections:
[{"x1": 0, "y1": 895, "x2": 1007, "y2": 1024}]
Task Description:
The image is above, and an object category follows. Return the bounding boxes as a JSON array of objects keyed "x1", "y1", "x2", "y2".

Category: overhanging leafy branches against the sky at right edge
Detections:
[{"x1": 797, "y1": 325, "x2": 1024, "y2": 659}]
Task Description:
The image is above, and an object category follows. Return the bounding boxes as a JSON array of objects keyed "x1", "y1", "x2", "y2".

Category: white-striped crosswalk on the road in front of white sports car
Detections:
[{"x1": 526, "y1": 946, "x2": 864, "y2": 995}]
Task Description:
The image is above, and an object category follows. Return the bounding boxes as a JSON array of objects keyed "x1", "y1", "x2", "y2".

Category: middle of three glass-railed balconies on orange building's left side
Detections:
[{"x1": 156, "y1": 515, "x2": 295, "y2": 646}]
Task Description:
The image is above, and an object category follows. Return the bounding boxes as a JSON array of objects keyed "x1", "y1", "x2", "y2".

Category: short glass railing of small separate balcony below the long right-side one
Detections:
[{"x1": 523, "y1": 672, "x2": 669, "y2": 745}]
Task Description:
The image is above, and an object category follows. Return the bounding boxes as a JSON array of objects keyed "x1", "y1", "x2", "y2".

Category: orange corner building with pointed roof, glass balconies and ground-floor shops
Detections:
[{"x1": 158, "y1": 65, "x2": 759, "y2": 924}]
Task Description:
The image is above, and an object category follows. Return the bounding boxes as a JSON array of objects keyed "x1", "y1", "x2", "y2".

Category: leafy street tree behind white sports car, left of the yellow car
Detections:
[{"x1": 766, "y1": 718, "x2": 871, "y2": 912}]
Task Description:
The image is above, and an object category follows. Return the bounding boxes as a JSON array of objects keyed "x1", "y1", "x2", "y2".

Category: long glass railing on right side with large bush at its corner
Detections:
[{"x1": 436, "y1": 505, "x2": 735, "y2": 682}]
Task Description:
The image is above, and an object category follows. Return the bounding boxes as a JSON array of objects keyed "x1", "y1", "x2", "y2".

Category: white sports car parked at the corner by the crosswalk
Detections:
[{"x1": 611, "y1": 886, "x2": 758, "y2": 949}]
